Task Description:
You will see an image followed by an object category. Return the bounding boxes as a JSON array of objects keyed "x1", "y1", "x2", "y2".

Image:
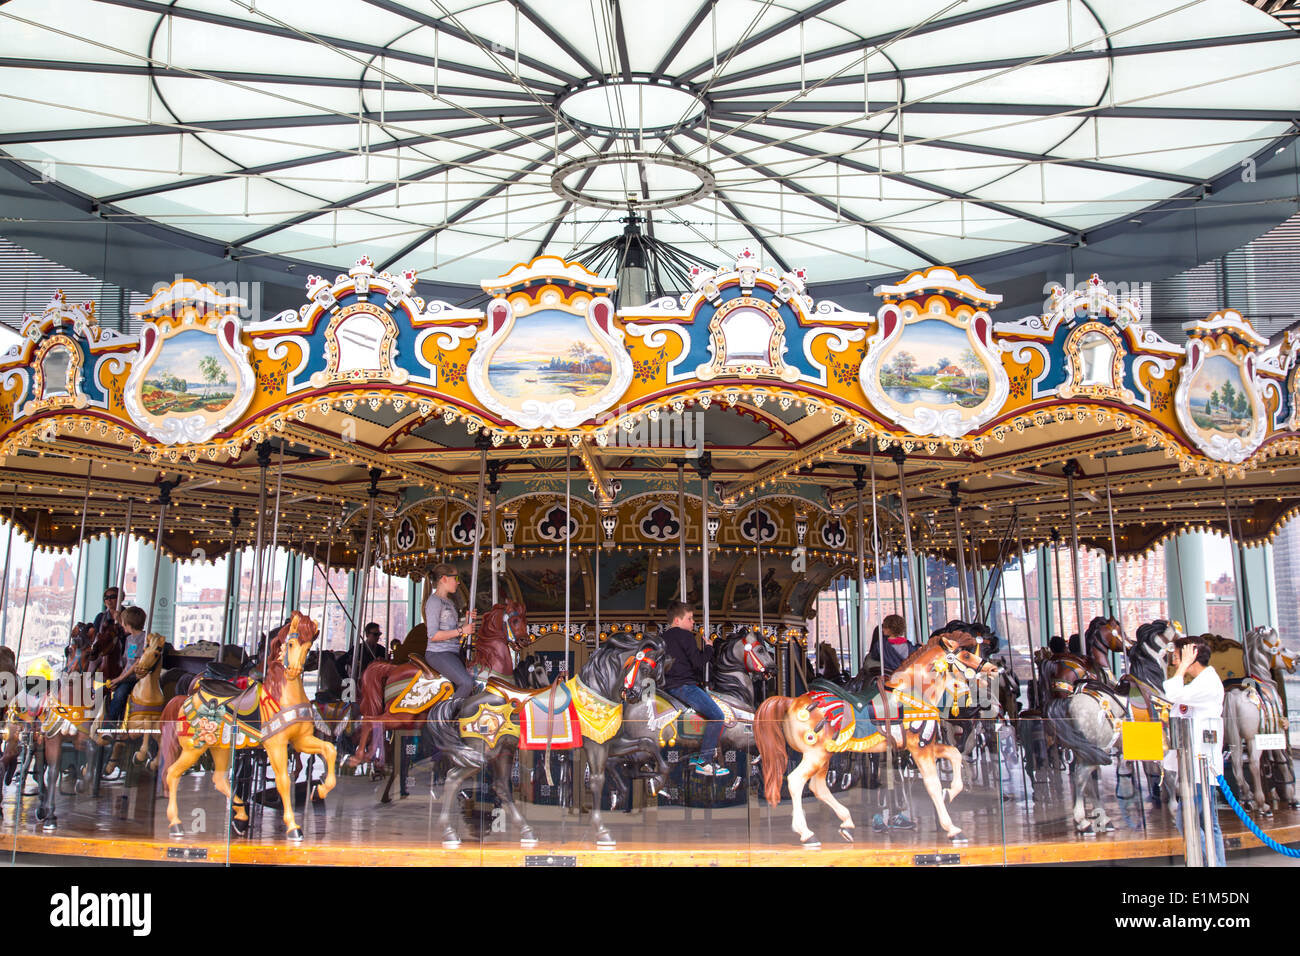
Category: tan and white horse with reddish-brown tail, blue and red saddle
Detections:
[{"x1": 754, "y1": 631, "x2": 997, "y2": 847}]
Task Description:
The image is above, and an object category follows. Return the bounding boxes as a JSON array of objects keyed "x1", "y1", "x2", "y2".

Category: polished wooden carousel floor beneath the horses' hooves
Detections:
[{"x1": 0, "y1": 769, "x2": 1300, "y2": 866}]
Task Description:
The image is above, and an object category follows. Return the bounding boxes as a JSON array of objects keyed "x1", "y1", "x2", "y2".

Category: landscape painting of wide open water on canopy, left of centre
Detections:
[{"x1": 488, "y1": 310, "x2": 614, "y2": 405}]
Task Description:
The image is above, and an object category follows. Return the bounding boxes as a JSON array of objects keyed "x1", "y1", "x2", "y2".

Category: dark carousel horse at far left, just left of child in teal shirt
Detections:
[{"x1": 31, "y1": 628, "x2": 108, "y2": 830}]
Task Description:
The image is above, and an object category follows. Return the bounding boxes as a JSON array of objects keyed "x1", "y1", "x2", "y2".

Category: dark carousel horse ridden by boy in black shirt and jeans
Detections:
[{"x1": 607, "y1": 628, "x2": 776, "y2": 799}]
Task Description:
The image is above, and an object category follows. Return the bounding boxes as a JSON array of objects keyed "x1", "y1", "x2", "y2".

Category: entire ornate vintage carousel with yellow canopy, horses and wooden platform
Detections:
[{"x1": 0, "y1": 256, "x2": 1300, "y2": 865}]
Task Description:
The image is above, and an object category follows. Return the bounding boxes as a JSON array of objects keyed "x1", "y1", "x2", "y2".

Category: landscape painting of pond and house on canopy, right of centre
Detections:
[{"x1": 880, "y1": 319, "x2": 988, "y2": 408}]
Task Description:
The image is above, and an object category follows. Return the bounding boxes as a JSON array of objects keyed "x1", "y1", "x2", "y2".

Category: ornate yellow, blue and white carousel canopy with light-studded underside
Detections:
[{"x1": 0, "y1": 250, "x2": 1300, "y2": 600}]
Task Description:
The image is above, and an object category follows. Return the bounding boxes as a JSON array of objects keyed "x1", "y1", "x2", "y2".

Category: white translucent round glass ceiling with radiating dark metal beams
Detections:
[{"x1": 0, "y1": 0, "x2": 1300, "y2": 285}]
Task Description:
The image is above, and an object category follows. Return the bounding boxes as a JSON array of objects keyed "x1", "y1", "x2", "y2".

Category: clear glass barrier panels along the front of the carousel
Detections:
[{"x1": 0, "y1": 696, "x2": 1300, "y2": 865}]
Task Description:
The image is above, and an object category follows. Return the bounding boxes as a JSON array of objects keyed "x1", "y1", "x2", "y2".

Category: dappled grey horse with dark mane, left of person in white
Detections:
[{"x1": 1044, "y1": 618, "x2": 1164, "y2": 835}]
